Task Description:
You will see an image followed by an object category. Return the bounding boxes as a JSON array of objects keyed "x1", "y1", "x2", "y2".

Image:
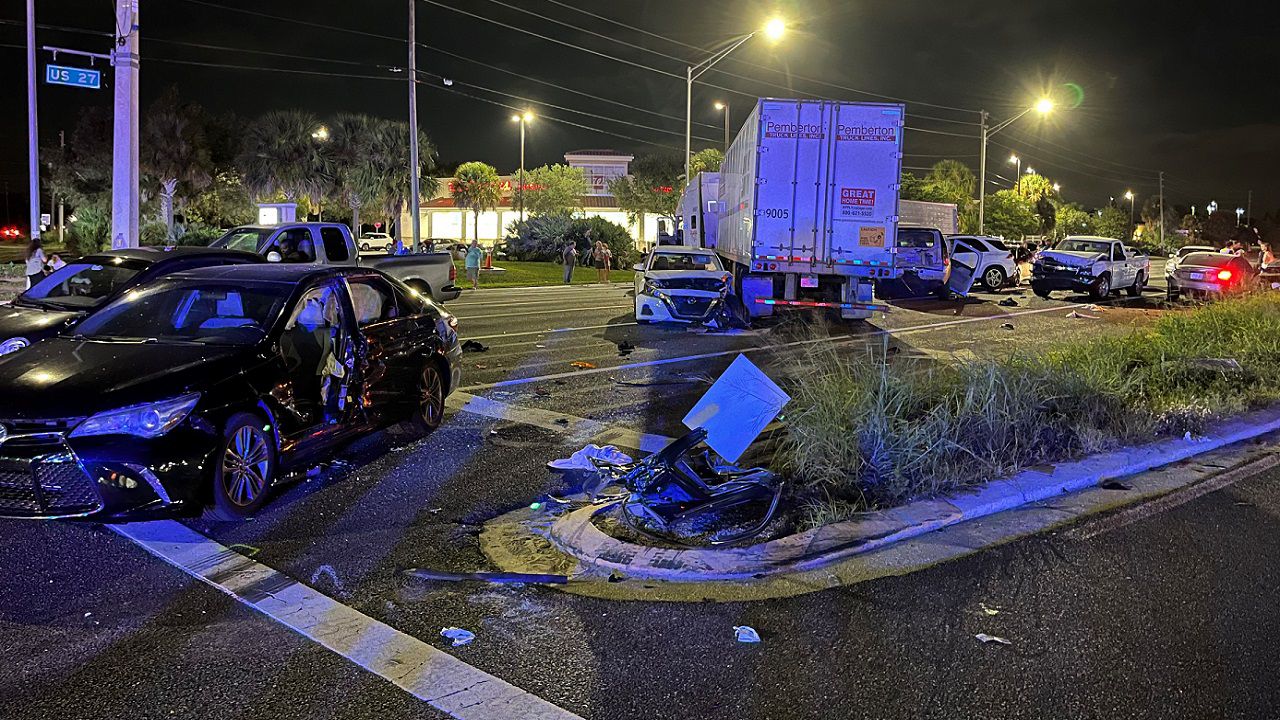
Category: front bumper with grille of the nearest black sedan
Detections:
[{"x1": 0, "y1": 425, "x2": 215, "y2": 521}]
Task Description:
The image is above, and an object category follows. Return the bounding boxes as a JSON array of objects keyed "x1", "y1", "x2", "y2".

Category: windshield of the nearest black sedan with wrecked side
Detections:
[{"x1": 73, "y1": 279, "x2": 293, "y2": 345}]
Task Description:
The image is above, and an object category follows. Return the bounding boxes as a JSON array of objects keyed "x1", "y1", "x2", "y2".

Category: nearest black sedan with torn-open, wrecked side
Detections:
[{"x1": 0, "y1": 264, "x2": 461, "y2": 521}]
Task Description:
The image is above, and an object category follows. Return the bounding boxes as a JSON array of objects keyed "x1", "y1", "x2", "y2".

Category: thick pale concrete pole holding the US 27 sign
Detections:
[{"x1": 111, "y1": 0, "x2": 140, "y2": 250}]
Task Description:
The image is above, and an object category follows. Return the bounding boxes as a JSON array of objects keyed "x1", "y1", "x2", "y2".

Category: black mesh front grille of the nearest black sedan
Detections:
[{"x1": 0, "y1": 436, "x2": 102, "y2": 518}]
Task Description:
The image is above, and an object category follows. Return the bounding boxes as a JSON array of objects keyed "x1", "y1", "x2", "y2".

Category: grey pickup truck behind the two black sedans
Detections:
[{"x1": 212, "y1": 223, "x2": 462, "y2": 302}]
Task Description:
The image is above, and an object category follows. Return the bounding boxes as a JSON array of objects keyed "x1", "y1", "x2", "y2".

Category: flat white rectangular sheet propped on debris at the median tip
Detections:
[{"x1": 684, "y1": 355, "x2": 791, "y2": 462}]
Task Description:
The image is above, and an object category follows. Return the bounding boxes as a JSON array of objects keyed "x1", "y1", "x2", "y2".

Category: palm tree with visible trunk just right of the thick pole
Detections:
[{"x1": 141, "y1": 88, "x2": 212, "y2": 241}]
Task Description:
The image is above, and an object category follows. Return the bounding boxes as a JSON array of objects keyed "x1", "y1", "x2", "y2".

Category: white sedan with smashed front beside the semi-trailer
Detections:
[{"x1": 635, "y1": 245, "x2": 733, "y2": 324}]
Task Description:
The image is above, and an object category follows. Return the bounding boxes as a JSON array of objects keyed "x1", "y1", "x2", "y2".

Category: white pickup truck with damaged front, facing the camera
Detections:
[{"x1": 1032, "y1": 236, "x2": 1151, "y2": 300}]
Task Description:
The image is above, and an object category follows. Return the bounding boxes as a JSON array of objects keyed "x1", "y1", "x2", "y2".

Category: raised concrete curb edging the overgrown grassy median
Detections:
[{"x1": 535, "y1": 407, "x2": 1280, "y2": 583}]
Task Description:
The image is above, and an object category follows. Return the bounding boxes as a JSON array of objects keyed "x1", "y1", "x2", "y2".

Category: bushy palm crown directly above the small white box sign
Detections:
[{"x1": 239, "y1": 110, "x2": 330, "y2": 210}]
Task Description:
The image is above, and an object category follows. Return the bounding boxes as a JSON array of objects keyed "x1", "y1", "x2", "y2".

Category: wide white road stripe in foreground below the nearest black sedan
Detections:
[{"x1": 109, "y1": 520, "x2": 577, "y2": 720}]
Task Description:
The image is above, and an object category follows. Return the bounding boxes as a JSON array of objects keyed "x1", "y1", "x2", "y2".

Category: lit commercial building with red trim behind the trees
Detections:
[{"x1": 399, "y1": 150, "x2": 658, "y2": 249}]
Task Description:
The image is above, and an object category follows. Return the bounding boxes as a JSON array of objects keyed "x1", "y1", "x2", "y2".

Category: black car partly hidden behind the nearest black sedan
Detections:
[{"x1": 0, "y1": 247, "x2": 264, "y2": 355}]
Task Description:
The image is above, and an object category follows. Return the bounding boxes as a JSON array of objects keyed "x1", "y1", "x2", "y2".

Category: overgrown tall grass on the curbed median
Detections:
[{"x1": 780, "y1": 293, "x2": 1280, "y2": 524}]
